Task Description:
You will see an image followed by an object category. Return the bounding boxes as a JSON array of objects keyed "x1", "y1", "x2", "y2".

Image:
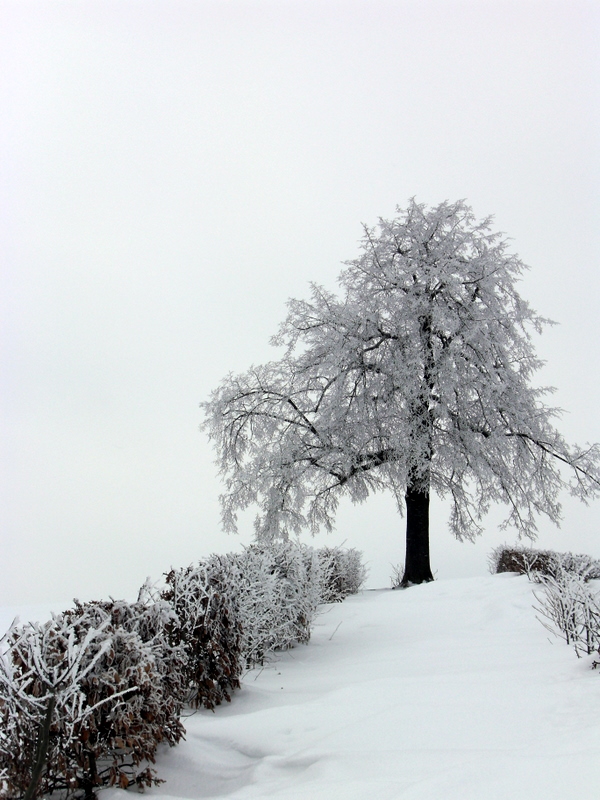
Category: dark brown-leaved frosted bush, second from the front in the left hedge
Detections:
[{"x1": 162, "y1": 562, "x2": 242, "y2": 709}]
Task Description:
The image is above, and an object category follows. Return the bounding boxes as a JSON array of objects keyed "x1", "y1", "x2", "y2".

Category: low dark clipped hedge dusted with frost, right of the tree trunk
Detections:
[{"x1": 489, "y1": 545, "x2": 600, "y2": 581}]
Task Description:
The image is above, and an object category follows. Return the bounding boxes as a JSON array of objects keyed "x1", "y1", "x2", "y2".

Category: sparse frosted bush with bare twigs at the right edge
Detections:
[{"x1": 535, "y1": 569, "x2": 600, "y2": 656}]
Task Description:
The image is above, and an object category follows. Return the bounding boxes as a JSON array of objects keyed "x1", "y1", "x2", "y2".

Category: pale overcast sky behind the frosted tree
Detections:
[{"x1": 0, "y1": 0, "x2": 600, "y2": 604}]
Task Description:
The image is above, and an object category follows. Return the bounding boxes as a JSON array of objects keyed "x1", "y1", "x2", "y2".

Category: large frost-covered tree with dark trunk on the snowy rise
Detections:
[{"x1": 203, "y1": 201, "x2": 600, "y2": 585}]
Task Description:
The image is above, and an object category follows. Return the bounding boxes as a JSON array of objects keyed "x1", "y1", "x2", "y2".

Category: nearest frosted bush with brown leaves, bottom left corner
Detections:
[{"x1": 0, "y1": 604, "x2": 184, "y2": 798}]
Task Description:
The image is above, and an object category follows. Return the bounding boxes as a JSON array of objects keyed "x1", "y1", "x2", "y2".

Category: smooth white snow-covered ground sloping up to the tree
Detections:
[{"x1": 4, "y1": 574, "x2": 600, "y2": 800}]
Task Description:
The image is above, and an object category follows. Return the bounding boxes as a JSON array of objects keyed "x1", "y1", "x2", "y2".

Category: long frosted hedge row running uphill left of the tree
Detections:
[{"x1": 0, "y1": 543, "x2": 365, "y2": 800}]
